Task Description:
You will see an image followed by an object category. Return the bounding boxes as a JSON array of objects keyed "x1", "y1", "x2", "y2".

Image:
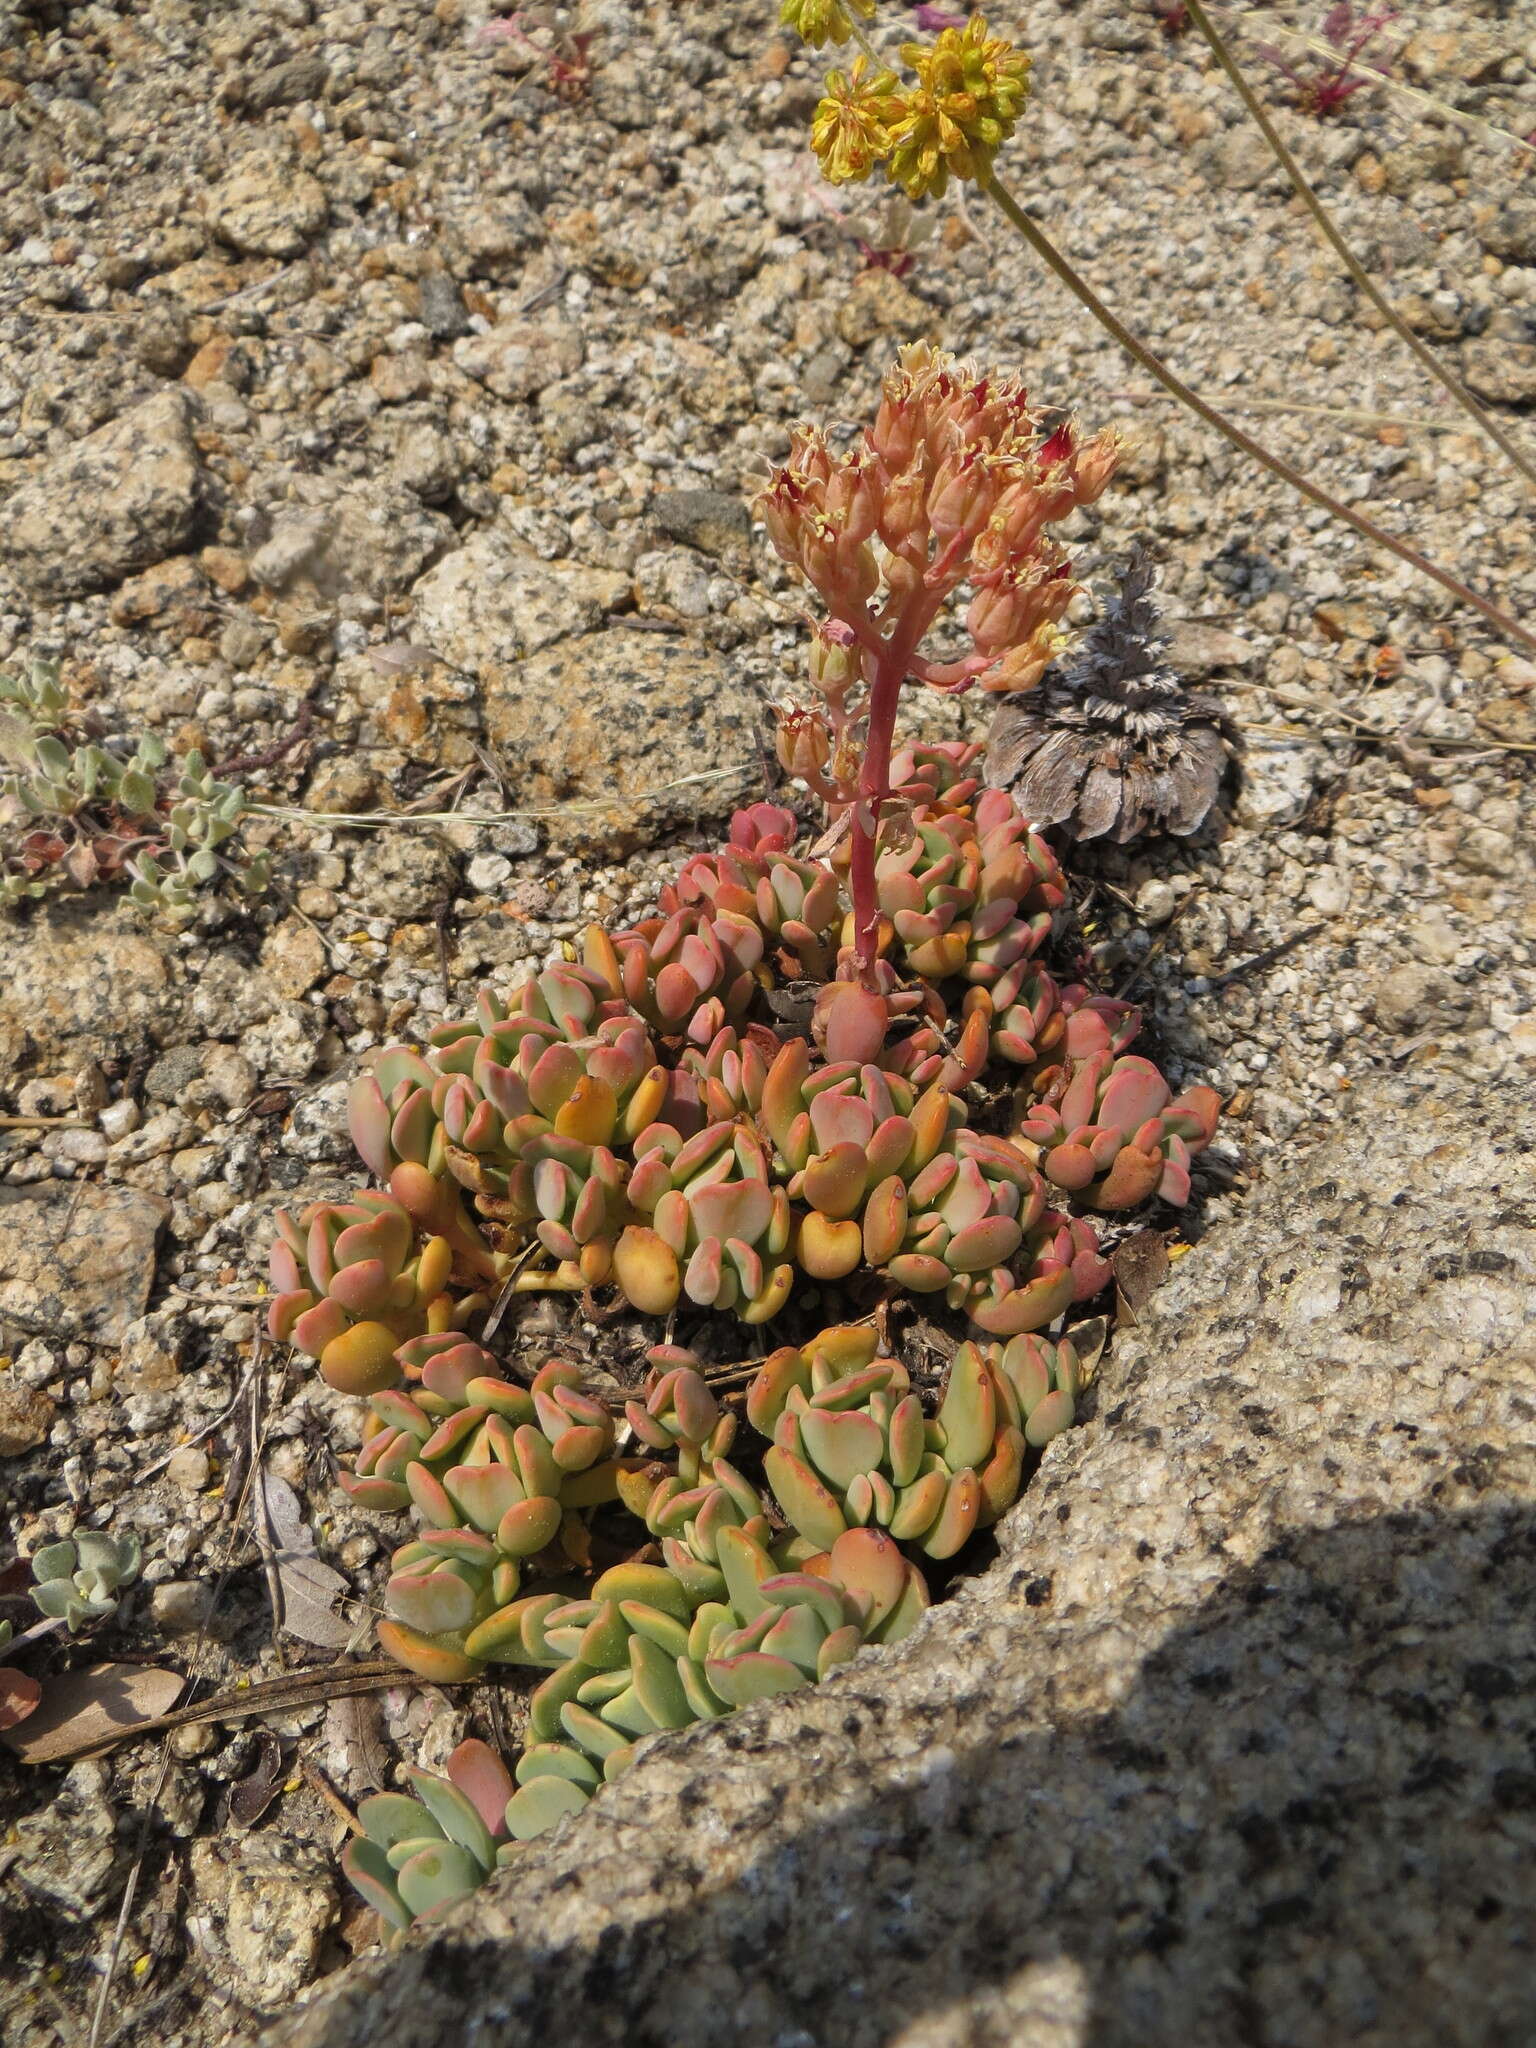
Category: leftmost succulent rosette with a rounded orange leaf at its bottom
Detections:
[{"x1": 266, "y1": 1188, "x2": 475, "y2": 1395}]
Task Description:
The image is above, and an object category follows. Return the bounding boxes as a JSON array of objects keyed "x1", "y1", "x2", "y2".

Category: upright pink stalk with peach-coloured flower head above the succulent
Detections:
[{"x1": 758, "y1": 342, "x2": 1120, "y2": 985}]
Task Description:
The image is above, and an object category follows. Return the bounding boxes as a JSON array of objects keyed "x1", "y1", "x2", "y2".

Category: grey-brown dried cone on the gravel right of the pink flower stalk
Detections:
[{"x1": 987, "y1": 547, "x2": 1229, "y2": 844}]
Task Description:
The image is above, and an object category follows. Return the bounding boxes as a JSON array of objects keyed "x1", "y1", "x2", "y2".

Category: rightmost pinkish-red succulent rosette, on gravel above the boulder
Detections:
[{"x1": 1014, "y1": 1047, "x2": 1221, "y2": 1210}]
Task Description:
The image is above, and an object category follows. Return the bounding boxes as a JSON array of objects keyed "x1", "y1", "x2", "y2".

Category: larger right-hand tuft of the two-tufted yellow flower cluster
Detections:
[{"x1": 885, "y1": 14, "x2": 1030, "y2": 199}]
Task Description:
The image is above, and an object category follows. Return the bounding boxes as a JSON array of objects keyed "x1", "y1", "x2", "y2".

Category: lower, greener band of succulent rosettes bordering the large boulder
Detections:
[{"x1": 342, "y1": 1323, "x2": 1081, "y2": 1937}]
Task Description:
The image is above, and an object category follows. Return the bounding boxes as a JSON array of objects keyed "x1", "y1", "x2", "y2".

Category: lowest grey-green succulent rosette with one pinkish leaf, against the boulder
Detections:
[{"x1": 342, "y1": 1739, "x2": 516, "y2": 1937}]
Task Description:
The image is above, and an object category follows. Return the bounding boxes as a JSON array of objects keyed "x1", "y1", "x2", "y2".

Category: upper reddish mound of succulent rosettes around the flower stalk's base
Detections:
[{"x1": 270, "y1": 770, "x2": 1217, "y2": 1395}]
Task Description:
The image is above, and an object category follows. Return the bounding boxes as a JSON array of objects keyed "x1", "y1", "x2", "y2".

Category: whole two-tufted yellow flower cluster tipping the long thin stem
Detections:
[{"x1": 807, "y1": 15, "x2": 1030, "y2": 199}]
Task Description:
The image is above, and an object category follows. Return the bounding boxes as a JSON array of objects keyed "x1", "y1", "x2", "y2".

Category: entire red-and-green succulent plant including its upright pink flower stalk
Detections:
[{"x1": 268, "y1": 348, "x2": 1217, "y2": 1927}]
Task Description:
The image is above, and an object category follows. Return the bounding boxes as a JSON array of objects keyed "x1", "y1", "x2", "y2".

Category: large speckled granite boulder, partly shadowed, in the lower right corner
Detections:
[{"x1": 276, "y1": 1073, "x2": 1536, "y2": 2048}]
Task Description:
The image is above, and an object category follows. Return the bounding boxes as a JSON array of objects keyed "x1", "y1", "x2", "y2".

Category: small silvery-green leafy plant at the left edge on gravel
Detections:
[{"x1": 0, "y1": 662, "x2": 268, "y2": 924}]
